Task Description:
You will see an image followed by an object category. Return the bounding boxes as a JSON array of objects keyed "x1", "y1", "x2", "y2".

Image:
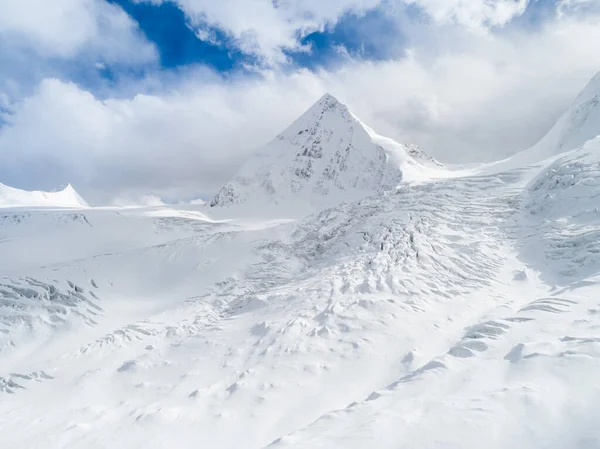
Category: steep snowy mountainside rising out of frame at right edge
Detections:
[{"x1": 527, "y1": 72, "x2": 600, "y2": 157}]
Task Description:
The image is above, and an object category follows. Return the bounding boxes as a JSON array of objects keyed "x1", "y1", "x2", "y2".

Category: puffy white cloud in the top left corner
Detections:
[{"x1": 0, "y1": 0, "x2": 158, "y2": 103}]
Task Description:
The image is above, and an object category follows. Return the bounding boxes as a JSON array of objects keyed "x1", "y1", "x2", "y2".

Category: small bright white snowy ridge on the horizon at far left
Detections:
[{"x1": 0, "y1": 183, "x2": 88, "y2": 208}]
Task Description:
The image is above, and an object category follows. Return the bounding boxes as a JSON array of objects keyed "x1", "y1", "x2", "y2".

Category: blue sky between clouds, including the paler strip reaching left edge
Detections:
[{"x1": 0, "y1": 0, "x2": 405, "y2": 105}]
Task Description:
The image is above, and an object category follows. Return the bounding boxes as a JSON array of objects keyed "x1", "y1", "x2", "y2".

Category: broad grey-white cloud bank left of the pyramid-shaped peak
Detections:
[{"x1": 0, "y1": 74, "x2": 312, "y2": 202}]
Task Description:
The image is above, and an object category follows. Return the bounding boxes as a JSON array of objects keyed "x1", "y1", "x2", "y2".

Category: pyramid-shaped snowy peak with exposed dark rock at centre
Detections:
[{"x1": 211, "y1": 94, "x2": 439, "y2": 211}]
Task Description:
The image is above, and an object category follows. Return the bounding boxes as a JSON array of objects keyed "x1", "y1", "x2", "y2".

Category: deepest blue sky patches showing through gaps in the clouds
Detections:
[{"x1": 111, "y1": 0, "x2": 401, "y2": 72}]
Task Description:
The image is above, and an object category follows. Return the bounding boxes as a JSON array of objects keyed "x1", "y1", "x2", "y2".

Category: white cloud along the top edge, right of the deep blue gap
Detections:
[{"x1": 136, "y1": 0, "x2": 536, "y2": 65}]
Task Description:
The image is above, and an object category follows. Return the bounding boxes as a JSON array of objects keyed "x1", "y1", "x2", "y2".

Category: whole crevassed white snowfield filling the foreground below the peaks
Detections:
[{"x1": 0, "y1": 79, "x2": 600, "y2": 449}]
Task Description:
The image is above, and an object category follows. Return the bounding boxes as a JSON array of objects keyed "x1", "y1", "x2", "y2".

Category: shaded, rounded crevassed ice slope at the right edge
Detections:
[{"x1": 524, "y1": 138, "x2": 600, "y2": 282}]
